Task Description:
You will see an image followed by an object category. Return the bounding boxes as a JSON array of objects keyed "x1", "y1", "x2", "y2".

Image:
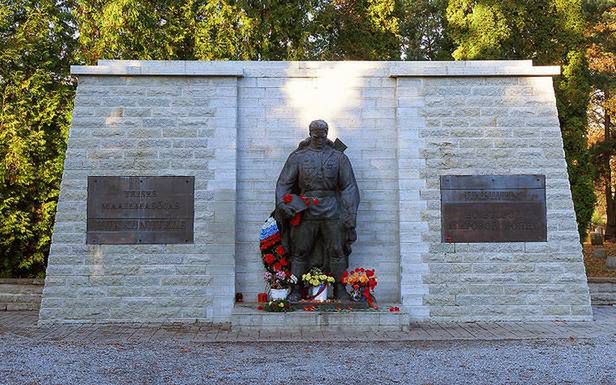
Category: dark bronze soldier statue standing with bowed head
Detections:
[{"x1": 275, "y1": 120, "x2": 359, "y2": 302}]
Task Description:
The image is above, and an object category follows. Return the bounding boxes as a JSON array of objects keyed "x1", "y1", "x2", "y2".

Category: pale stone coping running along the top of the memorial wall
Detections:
[{"x1": 71, "y1": 60, "x2": 560, "y2": 77}]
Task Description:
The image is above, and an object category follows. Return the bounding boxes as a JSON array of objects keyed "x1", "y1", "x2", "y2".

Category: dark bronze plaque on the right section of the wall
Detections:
[{"x1": 441, "y1": 175, "x2": 547, "y2": 243}]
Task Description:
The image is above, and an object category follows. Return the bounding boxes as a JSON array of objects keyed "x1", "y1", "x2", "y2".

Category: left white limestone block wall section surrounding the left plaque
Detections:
[{"x1": 40, "y1": 74, "x2": 237, "y2": 323}]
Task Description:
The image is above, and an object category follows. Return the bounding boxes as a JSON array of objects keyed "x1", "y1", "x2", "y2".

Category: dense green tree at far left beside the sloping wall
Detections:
[{"x1": 0, "y1": 0, "x2": 75, "y2": 276}]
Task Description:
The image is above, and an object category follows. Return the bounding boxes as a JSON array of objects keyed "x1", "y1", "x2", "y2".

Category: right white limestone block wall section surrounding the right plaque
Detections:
[{"x1": 398, "y1": 76, "x2": 592, "y2": 321}]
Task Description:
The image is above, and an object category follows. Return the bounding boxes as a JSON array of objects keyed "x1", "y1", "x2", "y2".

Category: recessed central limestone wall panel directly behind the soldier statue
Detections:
[{"x1": 236, "y1": 62, "x2": 400, "y2": 302}]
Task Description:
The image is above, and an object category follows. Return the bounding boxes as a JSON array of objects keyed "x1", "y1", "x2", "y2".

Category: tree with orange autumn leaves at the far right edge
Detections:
[{"x1": 585, "y1": 1, "x2": 616, "y2": 241}]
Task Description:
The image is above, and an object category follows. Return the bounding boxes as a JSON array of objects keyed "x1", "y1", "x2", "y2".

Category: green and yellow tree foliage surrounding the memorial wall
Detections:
[{"x1": 0, "y1": 0, "x2": 616, "y2": 276}]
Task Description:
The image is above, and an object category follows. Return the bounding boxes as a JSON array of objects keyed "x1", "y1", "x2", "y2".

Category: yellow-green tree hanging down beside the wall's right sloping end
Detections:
[{"x1": 447, "y1": 0, "x2": 595, "y2": 238}]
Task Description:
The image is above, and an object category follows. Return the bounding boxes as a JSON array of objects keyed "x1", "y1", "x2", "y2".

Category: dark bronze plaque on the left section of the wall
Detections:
[{"x1": 86, "y1": 176, "x2": 195, "y2": 244}]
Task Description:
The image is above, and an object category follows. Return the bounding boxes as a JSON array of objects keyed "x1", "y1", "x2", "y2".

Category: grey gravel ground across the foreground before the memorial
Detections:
[{"x1": 0, "y1": 335, "x2": 616, "y2": 385}]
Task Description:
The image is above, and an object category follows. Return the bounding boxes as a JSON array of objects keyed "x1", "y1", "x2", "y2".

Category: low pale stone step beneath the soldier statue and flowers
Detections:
[{"x1": 231, "y1": 303, "x2": 410, "y2": 331}]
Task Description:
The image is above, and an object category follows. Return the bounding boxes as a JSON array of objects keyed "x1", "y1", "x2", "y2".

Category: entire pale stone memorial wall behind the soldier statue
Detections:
[{"x1": 40, "y1": 61, "x2": 591, "y2": 323}]
